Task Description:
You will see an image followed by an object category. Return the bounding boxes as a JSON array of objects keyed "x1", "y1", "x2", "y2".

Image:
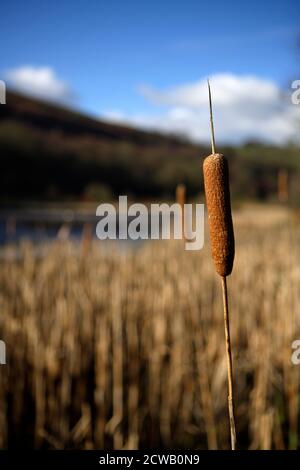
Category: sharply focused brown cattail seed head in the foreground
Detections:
[{"x1": 203, "y1": 153, "x2": 234, "y2": 277}]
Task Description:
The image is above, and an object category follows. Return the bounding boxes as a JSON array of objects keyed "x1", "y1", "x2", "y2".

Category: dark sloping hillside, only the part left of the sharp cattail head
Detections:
[{"x1": 0, "y1": 93, "x2": 206, "y2": 200}]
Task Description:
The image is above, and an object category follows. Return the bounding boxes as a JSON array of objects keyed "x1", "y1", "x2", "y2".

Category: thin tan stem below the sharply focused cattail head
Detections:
[{"x1": 222, "y1": 276, "x2": 236, "y2": 450}]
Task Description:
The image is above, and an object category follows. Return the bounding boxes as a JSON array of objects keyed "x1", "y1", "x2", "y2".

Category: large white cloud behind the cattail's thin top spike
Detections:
[{"x1": 101, "y1": 74, "x2": 300, "y2": 145}]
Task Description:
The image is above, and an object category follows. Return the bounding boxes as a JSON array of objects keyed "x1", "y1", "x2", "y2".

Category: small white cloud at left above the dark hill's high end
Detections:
[{"x1": 5, "y1": 65, "x2": 74, "y2": 102}]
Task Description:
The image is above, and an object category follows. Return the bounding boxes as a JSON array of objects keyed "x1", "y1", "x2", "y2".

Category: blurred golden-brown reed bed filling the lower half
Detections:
[{"x1": 0, "y1": 211, "x2": 300, "y2": 449}]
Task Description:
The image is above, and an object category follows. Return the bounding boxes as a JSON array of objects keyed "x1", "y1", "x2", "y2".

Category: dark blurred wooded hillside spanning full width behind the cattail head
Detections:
[{"x1": 0, "y1": 93, "x2": 300, "y2": 204}]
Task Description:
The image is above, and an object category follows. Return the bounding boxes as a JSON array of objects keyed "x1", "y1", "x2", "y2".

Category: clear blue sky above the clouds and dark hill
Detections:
[{"x1": 0, "y1": 0, "x2": 300, "y2": 143}]
